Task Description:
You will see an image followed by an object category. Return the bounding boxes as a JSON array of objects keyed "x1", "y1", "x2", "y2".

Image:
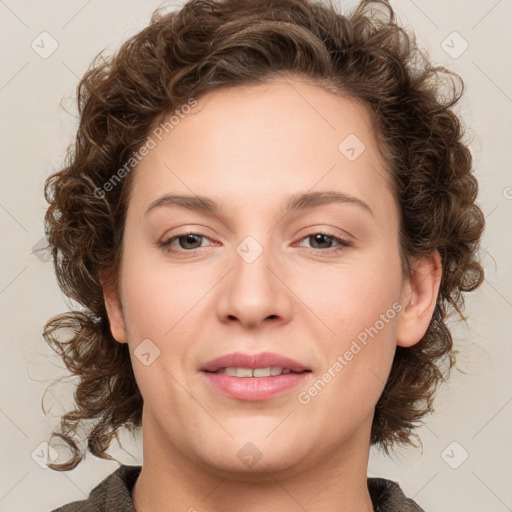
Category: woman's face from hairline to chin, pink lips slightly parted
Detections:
[{"x1": 103, "y1": 81, "x2": 420, "y2": 472}]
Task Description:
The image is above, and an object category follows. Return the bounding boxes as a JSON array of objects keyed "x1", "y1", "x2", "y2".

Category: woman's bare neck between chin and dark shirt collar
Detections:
[{"x1": 132, "y1": 408, "x2": 374, "y2": 512}]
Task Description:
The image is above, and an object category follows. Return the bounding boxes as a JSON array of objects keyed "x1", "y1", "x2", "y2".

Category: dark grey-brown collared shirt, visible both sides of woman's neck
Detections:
[{"x1": 52, "y1": 465, "x2": 424, "y2": 512}]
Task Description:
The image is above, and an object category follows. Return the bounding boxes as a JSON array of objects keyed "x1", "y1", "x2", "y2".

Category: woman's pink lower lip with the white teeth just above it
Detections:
[{"x1": 201, "y1": 371, "x2": 311, "y2": 402}]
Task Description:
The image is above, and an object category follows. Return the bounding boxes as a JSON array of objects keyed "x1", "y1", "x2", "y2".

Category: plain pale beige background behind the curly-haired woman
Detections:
[{"x1": 0, "y1": 0, "x2": 512, "y2": 512}]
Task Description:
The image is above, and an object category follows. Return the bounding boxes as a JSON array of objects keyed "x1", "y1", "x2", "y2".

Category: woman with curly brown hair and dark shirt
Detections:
[{"x1": 45, "y1": 0, "x2": 484, "y2": 512}]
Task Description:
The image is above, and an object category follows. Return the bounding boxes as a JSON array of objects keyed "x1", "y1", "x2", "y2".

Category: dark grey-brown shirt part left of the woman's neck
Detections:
[{"x1": 51, "y1": 465, "x2": 141, "y2": 512}]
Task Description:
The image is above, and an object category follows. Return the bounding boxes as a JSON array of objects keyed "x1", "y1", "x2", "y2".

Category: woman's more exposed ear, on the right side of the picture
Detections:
[{"x1": 396, "y1": 250, "x2": 442, "y2": 347}]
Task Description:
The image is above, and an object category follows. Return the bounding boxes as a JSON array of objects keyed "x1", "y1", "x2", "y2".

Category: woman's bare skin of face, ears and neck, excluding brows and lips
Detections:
[{"x1": 102, "y1": 78, "x2": 441, "y2": 512}]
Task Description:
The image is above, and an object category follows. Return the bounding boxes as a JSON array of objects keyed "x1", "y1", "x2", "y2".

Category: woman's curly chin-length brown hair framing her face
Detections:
[{"x1": 43, "y1": 0, "x2": 484, "y2": 471}]
